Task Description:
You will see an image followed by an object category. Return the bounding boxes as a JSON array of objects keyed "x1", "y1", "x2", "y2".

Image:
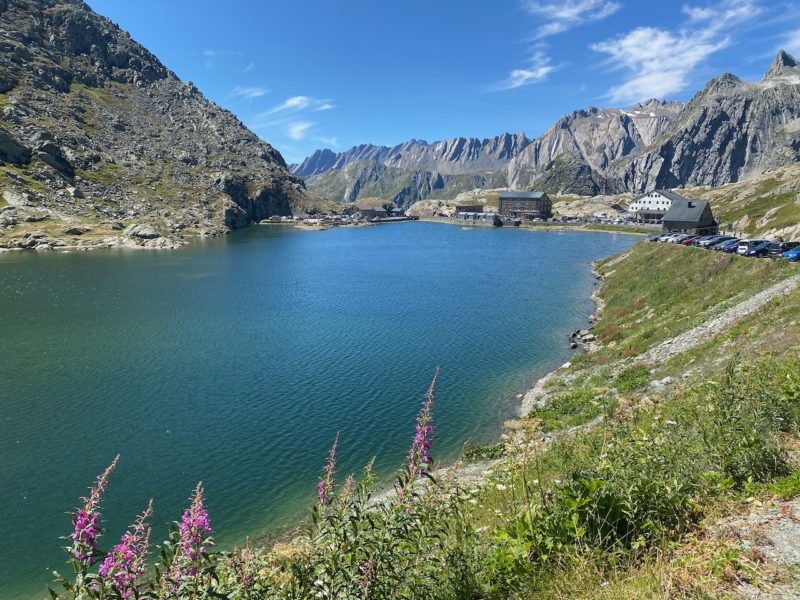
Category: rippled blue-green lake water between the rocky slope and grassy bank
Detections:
[{"x1": 0, "y1": 222, "x2": 638, "y2": 599}]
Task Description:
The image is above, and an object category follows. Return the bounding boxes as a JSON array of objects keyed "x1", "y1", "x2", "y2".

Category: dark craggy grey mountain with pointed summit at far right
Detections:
[{"x1": 606, "y1": 51, "x2": 800, "y2": 191}]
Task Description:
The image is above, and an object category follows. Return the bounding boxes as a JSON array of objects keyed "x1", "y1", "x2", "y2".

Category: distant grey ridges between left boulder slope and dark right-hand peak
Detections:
[{"x1": 290, "y1": 100, "x2": 683, "y2": 205}]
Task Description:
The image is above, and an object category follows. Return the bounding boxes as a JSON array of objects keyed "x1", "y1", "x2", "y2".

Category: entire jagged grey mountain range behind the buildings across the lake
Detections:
[{"x1": 293, "y1": 51, "x2": 800, "y2": 202}]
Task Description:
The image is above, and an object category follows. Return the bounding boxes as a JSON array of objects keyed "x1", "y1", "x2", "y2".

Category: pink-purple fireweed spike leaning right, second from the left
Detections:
[{"x1": 100, "y1": 500, "x2": 153, "y2": 599}]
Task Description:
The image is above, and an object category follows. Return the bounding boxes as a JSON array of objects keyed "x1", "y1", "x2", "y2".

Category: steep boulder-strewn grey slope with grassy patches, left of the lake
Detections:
[{"x1": 0, "y1": 0, "x2": 319, "y2": 247}]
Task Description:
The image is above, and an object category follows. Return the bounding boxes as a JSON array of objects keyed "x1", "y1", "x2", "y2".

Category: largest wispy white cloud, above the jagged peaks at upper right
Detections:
[{"x1": 591, "y1": 0, "x2": 762, "y2": 104}]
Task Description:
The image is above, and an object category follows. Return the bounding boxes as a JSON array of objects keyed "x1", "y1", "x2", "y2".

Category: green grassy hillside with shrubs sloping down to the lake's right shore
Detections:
[{"x1": 50, "y1": 242, "x2": 800, "y2": 599}]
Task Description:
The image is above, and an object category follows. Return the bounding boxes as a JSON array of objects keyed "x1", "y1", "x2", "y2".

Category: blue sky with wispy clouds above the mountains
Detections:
[{"x1": 89, "y1": 0, "x2": 800, "y2": 162}]
